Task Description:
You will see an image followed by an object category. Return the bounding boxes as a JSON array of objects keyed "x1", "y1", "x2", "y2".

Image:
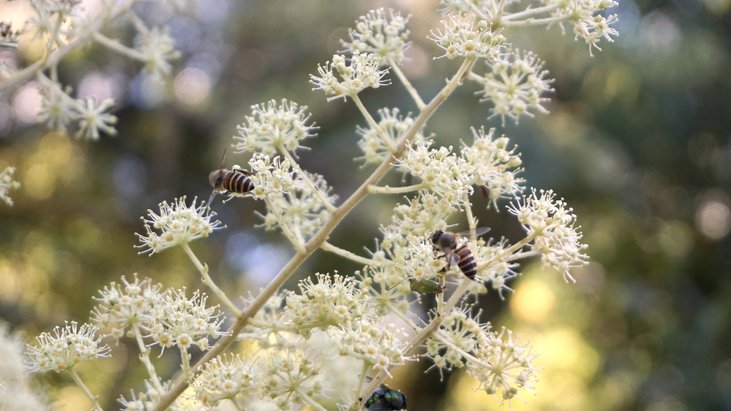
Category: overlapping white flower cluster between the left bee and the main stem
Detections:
[{"x1": 249, "y1": 153, "x2": 337, "y2": 246}]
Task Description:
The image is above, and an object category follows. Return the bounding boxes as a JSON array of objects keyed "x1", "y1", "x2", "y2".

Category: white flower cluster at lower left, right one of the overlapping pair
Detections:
[{"x1": 142, "y1": 288, "x2": 223, "y2": 351}]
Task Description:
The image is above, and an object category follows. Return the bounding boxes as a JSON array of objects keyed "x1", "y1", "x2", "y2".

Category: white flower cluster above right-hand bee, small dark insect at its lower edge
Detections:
[{"x1": 462, "y1": 127, "x2": 525, "y2": 206}]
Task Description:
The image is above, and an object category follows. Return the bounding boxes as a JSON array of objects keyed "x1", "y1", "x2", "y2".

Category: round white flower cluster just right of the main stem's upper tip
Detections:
[{"x1": 471, "y1": 49, "x2": 553, "y2": 122}]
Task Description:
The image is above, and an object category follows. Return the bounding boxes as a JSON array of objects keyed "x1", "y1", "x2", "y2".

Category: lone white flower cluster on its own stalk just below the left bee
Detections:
[{"x1": 135, "y1": 196, "x2": 223, "y2": 255}]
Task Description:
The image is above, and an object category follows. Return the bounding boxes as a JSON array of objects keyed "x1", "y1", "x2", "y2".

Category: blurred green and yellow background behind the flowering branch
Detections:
[{"x1": 0, "y1": 0, "x2": 731, "y2": 411}]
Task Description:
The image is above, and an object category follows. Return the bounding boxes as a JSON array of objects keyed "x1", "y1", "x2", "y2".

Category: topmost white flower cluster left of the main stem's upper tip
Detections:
[{"x1": 342, "y1": 8, "x2": 409, "y2": 64}]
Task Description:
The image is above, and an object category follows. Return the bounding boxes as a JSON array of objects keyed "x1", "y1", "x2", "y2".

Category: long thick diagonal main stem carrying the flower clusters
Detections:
[{"x1": 153, "y1": 58, "x2": 476, "y2": 411}]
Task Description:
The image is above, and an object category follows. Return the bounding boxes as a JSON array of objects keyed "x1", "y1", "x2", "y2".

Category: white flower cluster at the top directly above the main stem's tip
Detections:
[{"x1": 429, "y1": 14, "x2": 505, "y2": 60}]
